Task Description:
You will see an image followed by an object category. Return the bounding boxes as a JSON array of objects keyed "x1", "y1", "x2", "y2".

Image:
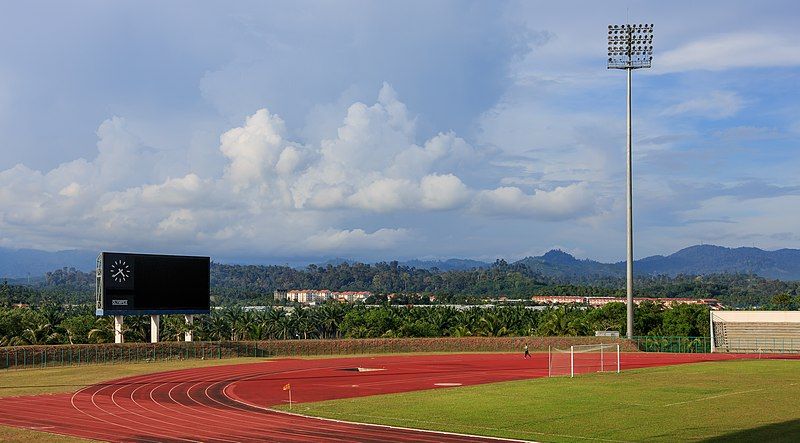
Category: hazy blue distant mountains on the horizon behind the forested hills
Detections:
[{"x1": 0, "y1": 245, "x2": 800, "y2": 280}]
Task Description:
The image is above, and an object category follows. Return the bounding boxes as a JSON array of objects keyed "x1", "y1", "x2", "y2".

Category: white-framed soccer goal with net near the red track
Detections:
[{"x1": 547, "y1": 344, "x2": 619, "y2": 377}]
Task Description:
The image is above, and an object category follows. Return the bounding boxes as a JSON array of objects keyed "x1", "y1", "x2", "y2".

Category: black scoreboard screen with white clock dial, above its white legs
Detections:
[{"x1": 95, "y1": 252, "x2": 211, "y2": 315}]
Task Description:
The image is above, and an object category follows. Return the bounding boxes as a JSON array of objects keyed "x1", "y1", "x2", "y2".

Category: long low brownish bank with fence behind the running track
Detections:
[{"x1": 0, "y1": 337, "x2": 636, "y2": 369}]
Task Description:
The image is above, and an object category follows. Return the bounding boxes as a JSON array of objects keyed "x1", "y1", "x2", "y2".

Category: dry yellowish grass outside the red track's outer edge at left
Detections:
[{"x1": 0, "y1": 358, "x2": 264, "y2": 443}]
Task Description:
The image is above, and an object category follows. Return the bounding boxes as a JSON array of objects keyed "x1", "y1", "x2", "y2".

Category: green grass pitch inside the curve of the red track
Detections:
[{"x1": 282, "y1": 360, "x2": 800, "y2": 442}]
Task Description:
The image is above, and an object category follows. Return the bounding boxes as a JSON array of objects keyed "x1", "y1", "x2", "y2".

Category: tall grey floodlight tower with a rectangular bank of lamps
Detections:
[{"x1": 608, "y1": 24, "x2": 653, "y2": 338}]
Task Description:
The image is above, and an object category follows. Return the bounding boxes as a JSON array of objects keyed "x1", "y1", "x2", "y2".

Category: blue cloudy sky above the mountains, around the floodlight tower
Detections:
[{"x1": 0, "y1": 0, "x2": 800, "y2": 262}]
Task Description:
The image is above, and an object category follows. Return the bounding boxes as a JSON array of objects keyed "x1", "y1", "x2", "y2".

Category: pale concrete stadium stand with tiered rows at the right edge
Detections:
[{"x1": 711, "y1": 311, "x2": 800, "y2": 353}]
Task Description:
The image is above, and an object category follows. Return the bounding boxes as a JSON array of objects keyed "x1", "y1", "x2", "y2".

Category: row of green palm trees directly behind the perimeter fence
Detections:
[{"x1": 0, "y1": 302, "x2": 708, "y2": 346}]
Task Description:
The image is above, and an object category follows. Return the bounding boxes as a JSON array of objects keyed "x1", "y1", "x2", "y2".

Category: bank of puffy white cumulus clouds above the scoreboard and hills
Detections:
[{"x1": 0, "y1": 84, "x2": 598, "y2": 256}]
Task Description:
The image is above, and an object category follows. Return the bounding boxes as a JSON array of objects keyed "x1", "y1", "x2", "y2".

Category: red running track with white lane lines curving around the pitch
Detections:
[{"x1": 0, "y1": 353, "x2": 796, "y2": 442}]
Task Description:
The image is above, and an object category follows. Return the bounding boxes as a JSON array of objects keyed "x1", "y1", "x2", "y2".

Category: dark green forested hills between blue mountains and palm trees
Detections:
[{"x1": 6, "y1": 260, "x2": 800, "y2": 307}]
